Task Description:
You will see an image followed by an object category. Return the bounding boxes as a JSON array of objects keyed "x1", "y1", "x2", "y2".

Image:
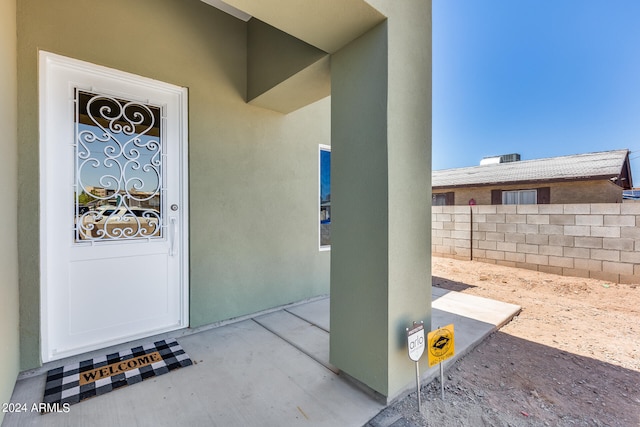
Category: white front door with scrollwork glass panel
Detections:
[{"x1": 40, "y1": 52, "x2": 188, "y2": 362}]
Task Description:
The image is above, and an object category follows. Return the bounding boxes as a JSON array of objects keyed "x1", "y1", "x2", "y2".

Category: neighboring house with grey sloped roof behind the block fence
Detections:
[{"x1": 432, "y1": 149, "x2": 633, "y2": 206}]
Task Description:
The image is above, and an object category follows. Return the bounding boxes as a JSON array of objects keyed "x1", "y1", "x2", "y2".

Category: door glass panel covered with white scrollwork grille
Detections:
[{"x1": 74, "y1": 90, "x2": 164, "y2": 242}]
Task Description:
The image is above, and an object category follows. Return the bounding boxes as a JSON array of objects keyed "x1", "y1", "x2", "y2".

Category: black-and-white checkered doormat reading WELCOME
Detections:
[{"x1": 44, "y1": 340, "x2": 192, "y2": 405}]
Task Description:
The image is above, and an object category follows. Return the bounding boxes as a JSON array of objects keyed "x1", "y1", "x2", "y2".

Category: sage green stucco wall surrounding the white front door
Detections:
[{"x1": 18, "y1": 0, "x2": 330, "y2": 369}]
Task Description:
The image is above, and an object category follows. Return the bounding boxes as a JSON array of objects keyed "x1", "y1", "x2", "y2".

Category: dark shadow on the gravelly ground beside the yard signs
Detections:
[{"x1": 367, "y1": 332, "x2": 640, "y2": 427}]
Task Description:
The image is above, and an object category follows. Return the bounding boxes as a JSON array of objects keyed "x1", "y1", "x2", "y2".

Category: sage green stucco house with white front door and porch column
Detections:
[{"x1": 0, "y1": 0, "x2": 431, "y2": 412}]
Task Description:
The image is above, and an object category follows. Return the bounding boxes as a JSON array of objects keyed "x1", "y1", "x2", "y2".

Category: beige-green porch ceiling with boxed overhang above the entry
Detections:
[{"x1": 202, "y1": 0, "x2": 385, "y2": 114}]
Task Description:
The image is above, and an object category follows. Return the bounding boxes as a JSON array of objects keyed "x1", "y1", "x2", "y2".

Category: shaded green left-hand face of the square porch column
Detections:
[{"x1": 330, "y1": 22, "x2": 389, "y2": 395}]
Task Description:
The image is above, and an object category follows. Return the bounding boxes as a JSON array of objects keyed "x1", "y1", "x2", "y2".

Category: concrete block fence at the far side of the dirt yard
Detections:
[{"x1": 431, "y1": 203, "x2": 640, "y2": 283}]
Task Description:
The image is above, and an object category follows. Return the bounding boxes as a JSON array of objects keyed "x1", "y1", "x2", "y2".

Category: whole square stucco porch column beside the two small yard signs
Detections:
[{"x1": 331, "y1": 0, "x2": 431, "y2": 400}]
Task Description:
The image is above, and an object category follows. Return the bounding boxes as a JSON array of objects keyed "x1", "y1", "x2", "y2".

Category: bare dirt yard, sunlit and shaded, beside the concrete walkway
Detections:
[{"x1": 389, "y1": 258, "x2": 640, "y2": 427}]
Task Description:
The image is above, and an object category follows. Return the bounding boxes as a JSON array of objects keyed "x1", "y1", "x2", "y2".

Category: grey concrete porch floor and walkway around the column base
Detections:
[{"x1": 2, "y1": 288, "x2": 520, "y2": 427}]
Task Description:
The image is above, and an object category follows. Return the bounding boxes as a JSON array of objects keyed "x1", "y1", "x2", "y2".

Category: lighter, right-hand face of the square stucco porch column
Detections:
[{"x1": 378, "y1": 0, "x2": 432, "y2": 397}]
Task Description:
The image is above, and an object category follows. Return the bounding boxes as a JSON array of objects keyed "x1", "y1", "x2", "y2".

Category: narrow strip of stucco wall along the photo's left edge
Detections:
[{"x1": 0, "y1": 0, "x2": 20, "y2": 424}]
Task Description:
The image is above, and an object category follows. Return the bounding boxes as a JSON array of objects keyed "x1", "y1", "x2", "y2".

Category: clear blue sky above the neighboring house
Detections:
[{"x1": 433, "y1": 0, "x2": 640, "y2": 182}]
